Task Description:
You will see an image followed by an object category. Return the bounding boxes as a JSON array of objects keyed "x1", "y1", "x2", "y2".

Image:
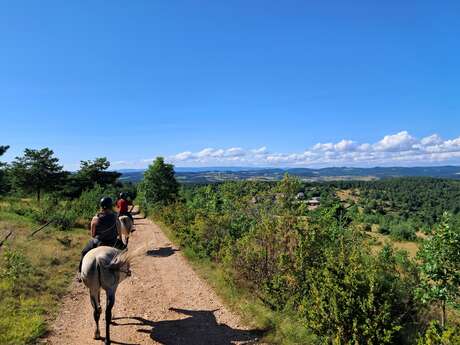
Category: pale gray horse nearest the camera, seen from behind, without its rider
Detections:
[{"x1": 81, "y1": 246, "x2": 131, "y2": 345}]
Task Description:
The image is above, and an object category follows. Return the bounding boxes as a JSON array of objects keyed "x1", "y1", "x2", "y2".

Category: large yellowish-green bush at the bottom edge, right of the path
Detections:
[{"x1": 302, "y1": 242, "x2": 406, "y2": 345}]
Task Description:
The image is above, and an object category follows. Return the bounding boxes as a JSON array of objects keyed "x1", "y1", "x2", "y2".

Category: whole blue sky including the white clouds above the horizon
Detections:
[{"x1": 0, "y1": 0, "x2": 460, "y2": 169}]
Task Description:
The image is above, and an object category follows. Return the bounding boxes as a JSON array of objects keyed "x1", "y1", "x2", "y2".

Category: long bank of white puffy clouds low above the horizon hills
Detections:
[{"x1": 147, "y1": 131, "x2": 460, "y2": 166}]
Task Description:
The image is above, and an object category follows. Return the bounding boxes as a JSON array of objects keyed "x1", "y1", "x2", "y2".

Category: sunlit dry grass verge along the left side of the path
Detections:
[{"x1": 0, "y1": 204, "x2": 88, "y2": 345}]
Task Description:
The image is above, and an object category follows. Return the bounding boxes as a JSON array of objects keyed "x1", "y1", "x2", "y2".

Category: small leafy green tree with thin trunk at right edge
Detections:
[{"x1": 417, "y1": 213, "x2": 460, "y2": 327}]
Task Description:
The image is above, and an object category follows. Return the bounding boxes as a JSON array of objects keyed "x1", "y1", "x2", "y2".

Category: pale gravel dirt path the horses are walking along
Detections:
[{"x1": 41, "y1": 214, "x2": 258, "y2": 345}]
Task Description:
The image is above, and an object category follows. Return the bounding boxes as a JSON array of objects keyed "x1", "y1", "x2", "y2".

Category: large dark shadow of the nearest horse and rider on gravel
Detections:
[{"x1": 112, "y1": 308, "x2": 263, "y2": 345}]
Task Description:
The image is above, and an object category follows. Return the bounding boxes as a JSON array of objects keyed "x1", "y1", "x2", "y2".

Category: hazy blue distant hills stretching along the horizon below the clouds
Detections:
[{"x1": 118, "y1": 166, "x2": 460, "y2": 183}]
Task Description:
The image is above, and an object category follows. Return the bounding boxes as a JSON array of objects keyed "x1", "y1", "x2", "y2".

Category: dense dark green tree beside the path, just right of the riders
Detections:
[{"x1": 139, "y1": 157, "x2": 179, "y2": 205}]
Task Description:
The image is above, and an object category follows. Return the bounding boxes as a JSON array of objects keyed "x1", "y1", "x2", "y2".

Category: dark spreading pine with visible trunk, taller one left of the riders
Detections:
[{"x1": 10, "y1": 147, "x2": 65, "y2": 201}]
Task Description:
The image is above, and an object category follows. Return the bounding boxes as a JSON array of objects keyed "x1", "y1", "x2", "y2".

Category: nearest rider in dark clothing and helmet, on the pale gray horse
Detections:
[{"x1": 78, "y1": 197, "x2": 120, "y2": 272}]
